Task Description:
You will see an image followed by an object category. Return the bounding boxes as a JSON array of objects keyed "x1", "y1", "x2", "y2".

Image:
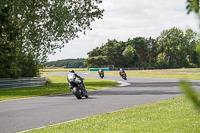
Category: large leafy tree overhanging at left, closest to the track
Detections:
[{"x1": 0, "y1": 0, "x2": 103, "y2": 77}]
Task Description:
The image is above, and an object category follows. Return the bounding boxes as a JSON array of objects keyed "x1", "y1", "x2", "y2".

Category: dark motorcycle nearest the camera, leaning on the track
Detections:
[{"x1": 70, "y1": 79, "x2": 88, "y2": 99}]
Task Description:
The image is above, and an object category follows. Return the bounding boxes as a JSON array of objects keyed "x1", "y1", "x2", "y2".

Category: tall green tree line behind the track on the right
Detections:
[{"x1": 85, "y1": 27, "x2": 200, "y2": 68}]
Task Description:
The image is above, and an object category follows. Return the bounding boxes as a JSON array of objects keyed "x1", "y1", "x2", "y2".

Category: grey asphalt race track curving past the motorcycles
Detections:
[{"x1": 0, "y1": 72, "x2": 200, "y2": 133}]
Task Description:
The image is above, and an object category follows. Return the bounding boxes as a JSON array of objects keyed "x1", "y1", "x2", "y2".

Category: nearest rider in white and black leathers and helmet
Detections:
[{"x1": 67, "y1": 70, "x2": 86, "y2": 91}]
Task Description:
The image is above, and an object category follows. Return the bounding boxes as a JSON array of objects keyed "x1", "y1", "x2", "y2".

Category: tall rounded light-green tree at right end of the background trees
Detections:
[{"x1": 157, "y1": 27, "x2": 196, "y2": 68}]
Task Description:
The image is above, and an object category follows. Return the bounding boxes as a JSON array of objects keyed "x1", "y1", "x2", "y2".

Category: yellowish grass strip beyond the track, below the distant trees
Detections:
[{"x1": 100, "y1": 68, "x2": 200, "y2": 80}]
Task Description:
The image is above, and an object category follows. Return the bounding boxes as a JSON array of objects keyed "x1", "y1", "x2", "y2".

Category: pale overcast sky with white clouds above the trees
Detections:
[{"x1": 49, "y1": 0, "x2": 198, "y2": 61}]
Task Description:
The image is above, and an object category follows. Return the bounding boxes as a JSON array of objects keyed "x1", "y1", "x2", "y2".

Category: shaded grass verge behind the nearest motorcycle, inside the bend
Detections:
[{"x1": 0, "y1": 75, "x2": 118, "y2": 101}]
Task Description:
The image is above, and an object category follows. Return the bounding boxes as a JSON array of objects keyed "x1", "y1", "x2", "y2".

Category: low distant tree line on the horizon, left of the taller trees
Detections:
[{"x1": 45, "y1": 58, "x2": 87, "y2": 68}]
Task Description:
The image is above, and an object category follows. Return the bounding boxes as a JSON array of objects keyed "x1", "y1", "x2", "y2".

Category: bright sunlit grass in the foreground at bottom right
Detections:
[{"x1": 26, "y1": 96, "x2": 200, "y2": 133}]
